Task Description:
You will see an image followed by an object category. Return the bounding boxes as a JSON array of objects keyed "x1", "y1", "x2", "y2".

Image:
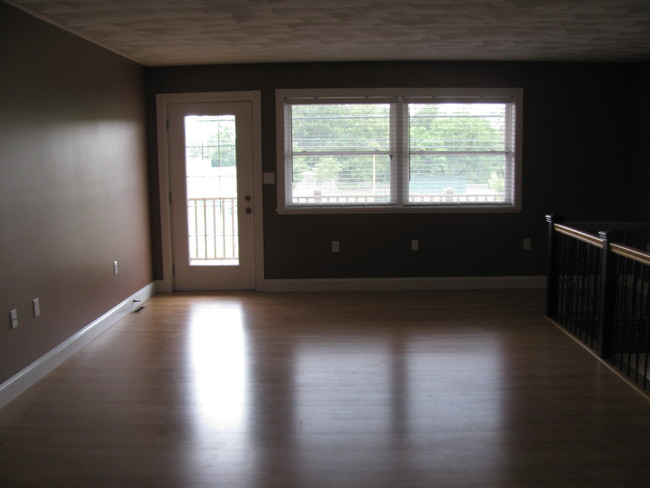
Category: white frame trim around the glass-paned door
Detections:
[{"x1": 156, "y1": 91, "x2": 264, "y2": 292}]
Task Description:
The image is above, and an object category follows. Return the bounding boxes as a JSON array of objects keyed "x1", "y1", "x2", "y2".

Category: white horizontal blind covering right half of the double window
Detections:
[{"x1": 408, "y1": 103, "x2": 514, "y2": 204}]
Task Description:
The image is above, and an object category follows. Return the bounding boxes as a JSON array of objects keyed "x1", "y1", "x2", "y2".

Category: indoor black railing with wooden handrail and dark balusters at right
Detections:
[{"x1": 546, "y1": 215, "x2": 650, "y2": 390}]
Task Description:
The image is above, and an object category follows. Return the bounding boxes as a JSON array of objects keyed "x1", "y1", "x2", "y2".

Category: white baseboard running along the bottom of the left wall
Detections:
[{"x1": 0, "y1": 283, "x2": 156, "y2": 408}]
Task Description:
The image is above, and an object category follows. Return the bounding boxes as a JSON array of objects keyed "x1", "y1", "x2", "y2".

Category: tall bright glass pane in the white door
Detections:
[{"x1": 185, "y1": 115, "x2": 239, "y2": 266}]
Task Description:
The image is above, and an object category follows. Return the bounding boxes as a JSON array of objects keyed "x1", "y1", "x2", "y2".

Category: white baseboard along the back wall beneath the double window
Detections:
[{"x1": 258, "y1": 276, "x2": 546, "y2": 292}]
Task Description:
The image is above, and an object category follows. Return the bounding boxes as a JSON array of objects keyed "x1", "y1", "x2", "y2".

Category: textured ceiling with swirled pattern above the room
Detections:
[{"x1": 7, "y1": 0, "x2": 650, "y2": 66}]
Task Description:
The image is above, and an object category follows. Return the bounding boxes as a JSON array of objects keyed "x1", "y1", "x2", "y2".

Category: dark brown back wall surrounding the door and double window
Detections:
[{"x1": 147, "y1": 62, "x2": 639, "y2": 278}]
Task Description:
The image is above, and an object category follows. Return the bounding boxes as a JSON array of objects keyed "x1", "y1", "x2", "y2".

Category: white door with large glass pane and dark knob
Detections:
[{"x1": 168, "y1": 102, "x2": 255, "y2": 290}]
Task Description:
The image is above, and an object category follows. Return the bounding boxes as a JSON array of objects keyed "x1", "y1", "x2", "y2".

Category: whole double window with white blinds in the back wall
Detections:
[{"x1": 276, "y1": 89, "x2": 521, "y2": 213}]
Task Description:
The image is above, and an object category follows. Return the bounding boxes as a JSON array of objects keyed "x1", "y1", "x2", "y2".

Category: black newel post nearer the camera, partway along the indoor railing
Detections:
[{"x1": 596, "y1": 231, "x2": 617, "y2": 358}]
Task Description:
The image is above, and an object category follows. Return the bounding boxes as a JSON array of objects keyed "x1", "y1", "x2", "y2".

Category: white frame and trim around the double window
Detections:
[{"x1": 275, "y1": 88, "x2": 523, "y2": 214}]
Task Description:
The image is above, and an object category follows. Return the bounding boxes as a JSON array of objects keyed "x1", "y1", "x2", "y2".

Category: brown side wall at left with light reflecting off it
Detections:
[{"x1": 0, "y1": 2, "x2": 152, "y2": 383}]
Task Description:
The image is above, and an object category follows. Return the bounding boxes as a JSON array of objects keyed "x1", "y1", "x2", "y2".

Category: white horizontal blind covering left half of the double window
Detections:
[{"x1": 287, "y1": 103, "x2": 391, "y2": 205}]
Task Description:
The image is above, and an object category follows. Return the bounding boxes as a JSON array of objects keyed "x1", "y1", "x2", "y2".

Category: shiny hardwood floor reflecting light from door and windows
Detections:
[{"x1": 0, "y1": 290, "x2": 650, "y2": 488}]
